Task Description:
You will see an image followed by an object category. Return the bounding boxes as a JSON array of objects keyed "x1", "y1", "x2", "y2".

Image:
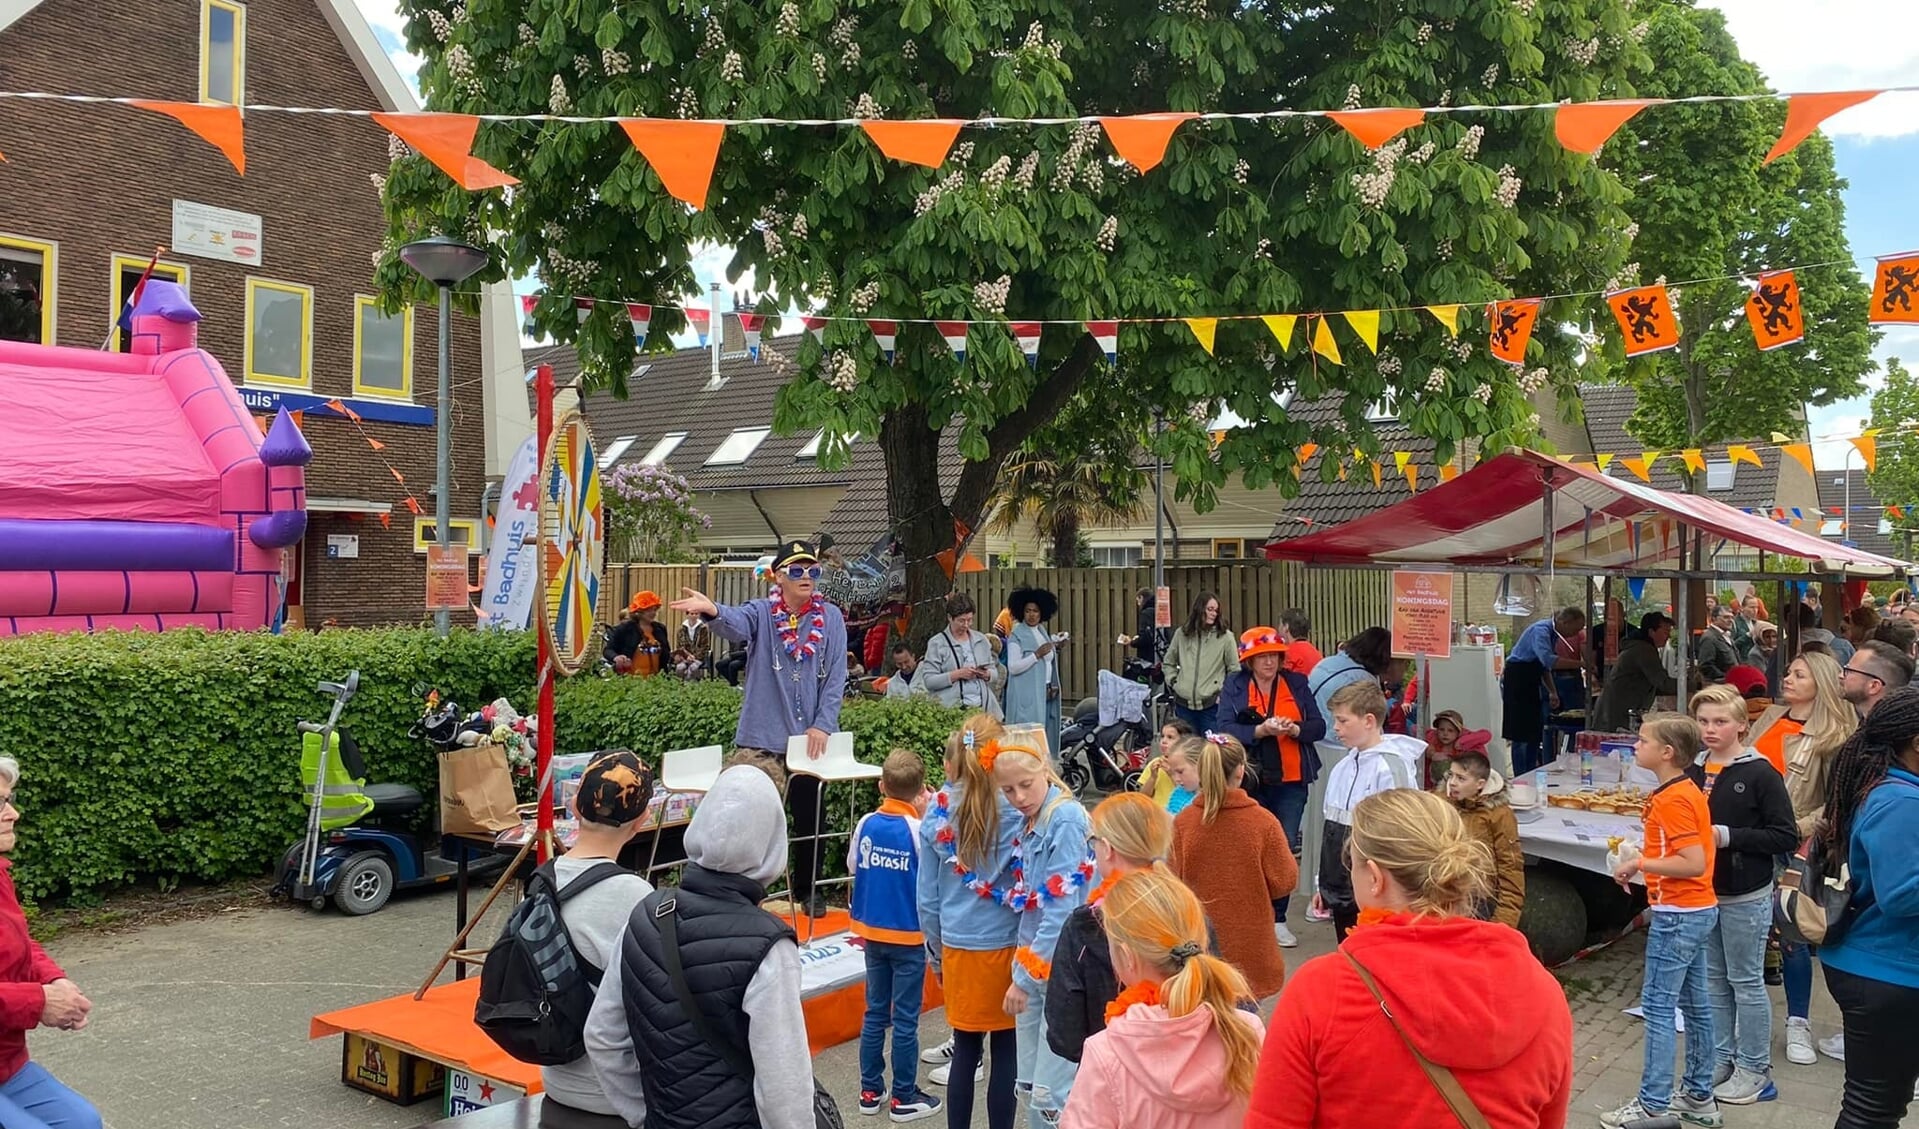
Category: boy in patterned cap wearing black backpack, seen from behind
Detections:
[{"x1": 474, "y1": 751, "x2": 652, "y2": 1116}]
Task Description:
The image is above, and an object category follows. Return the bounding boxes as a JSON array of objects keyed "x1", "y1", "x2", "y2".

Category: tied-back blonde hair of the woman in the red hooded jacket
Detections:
[{"x1": 1353, "y1": 787, "x2": 1493, "y2": 918}]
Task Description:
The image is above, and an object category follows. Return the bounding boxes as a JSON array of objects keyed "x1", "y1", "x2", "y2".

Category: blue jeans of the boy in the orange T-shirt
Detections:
[{"x1": 1639, "y1": 908, "x2": 1719, "y2": 1114}]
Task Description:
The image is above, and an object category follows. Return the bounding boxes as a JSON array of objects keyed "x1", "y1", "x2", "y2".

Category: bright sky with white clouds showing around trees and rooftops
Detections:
[{"x1": 353, "y1": 0, "x2": 1919, "y2": 458}]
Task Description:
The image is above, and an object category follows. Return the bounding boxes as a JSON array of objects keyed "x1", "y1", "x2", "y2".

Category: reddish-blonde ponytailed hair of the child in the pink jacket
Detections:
[{"x1": 1100, "y1": 867, "x2": 1258, "y2": 1100}]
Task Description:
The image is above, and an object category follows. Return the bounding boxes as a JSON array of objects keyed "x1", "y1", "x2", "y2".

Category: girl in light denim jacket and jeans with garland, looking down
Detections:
[{"x1": 981, "y1": 730, "x2": 1094, "y2": 1129}]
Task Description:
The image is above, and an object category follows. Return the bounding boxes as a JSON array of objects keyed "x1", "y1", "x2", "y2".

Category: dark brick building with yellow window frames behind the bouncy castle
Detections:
[{"x1": 0, "y1": 0, "x2": 532, "y2": 626}]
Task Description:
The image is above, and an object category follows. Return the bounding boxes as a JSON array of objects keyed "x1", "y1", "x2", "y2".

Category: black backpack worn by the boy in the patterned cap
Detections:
[{"x1": 474, "y1": 862, "x2": 631, "y2": 1066}]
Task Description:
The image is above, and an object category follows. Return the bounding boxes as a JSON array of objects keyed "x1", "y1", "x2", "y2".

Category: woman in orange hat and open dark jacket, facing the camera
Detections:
[{"x1": 1213, "y1": 626, "x2": 1326, "y2": 949}]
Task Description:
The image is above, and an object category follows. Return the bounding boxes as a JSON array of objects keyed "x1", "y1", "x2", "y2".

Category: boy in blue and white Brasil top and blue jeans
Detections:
[{"x1": 846, "y1": 749, "x2": 942, "y2": 1121}]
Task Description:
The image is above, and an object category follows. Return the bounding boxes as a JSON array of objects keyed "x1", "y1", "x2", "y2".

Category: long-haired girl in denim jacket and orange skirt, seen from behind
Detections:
[{"x1": 917, "y1": 714, "x2": 1021, "y2": 1129}]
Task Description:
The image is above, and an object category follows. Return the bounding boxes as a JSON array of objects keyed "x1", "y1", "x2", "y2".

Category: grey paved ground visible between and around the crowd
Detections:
[{"x1": 31, "y1": 893, "x2": 1919, "y2": 1129}]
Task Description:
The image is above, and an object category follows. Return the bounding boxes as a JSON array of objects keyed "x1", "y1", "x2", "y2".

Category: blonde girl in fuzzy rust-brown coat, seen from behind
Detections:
[{"x1": 1171, "y1": 733, "x2": 1299, "y2": 1000}]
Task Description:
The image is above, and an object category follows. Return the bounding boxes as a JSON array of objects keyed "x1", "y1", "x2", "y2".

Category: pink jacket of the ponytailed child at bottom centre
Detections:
[{"x1": 1059, "y1": 1004, "x2": 1265, "y2": 1129}]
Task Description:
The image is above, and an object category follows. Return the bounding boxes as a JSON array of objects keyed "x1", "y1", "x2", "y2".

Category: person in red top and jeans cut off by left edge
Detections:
[{"x1": 0, "y1": 757, "x2": 100, "y2": 1129}]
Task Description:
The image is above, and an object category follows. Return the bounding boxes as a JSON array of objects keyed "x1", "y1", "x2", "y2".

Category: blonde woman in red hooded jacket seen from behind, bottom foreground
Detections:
[{"x1": 1245, "y1": 789, "x2": 1572, "y2": 1129}]
